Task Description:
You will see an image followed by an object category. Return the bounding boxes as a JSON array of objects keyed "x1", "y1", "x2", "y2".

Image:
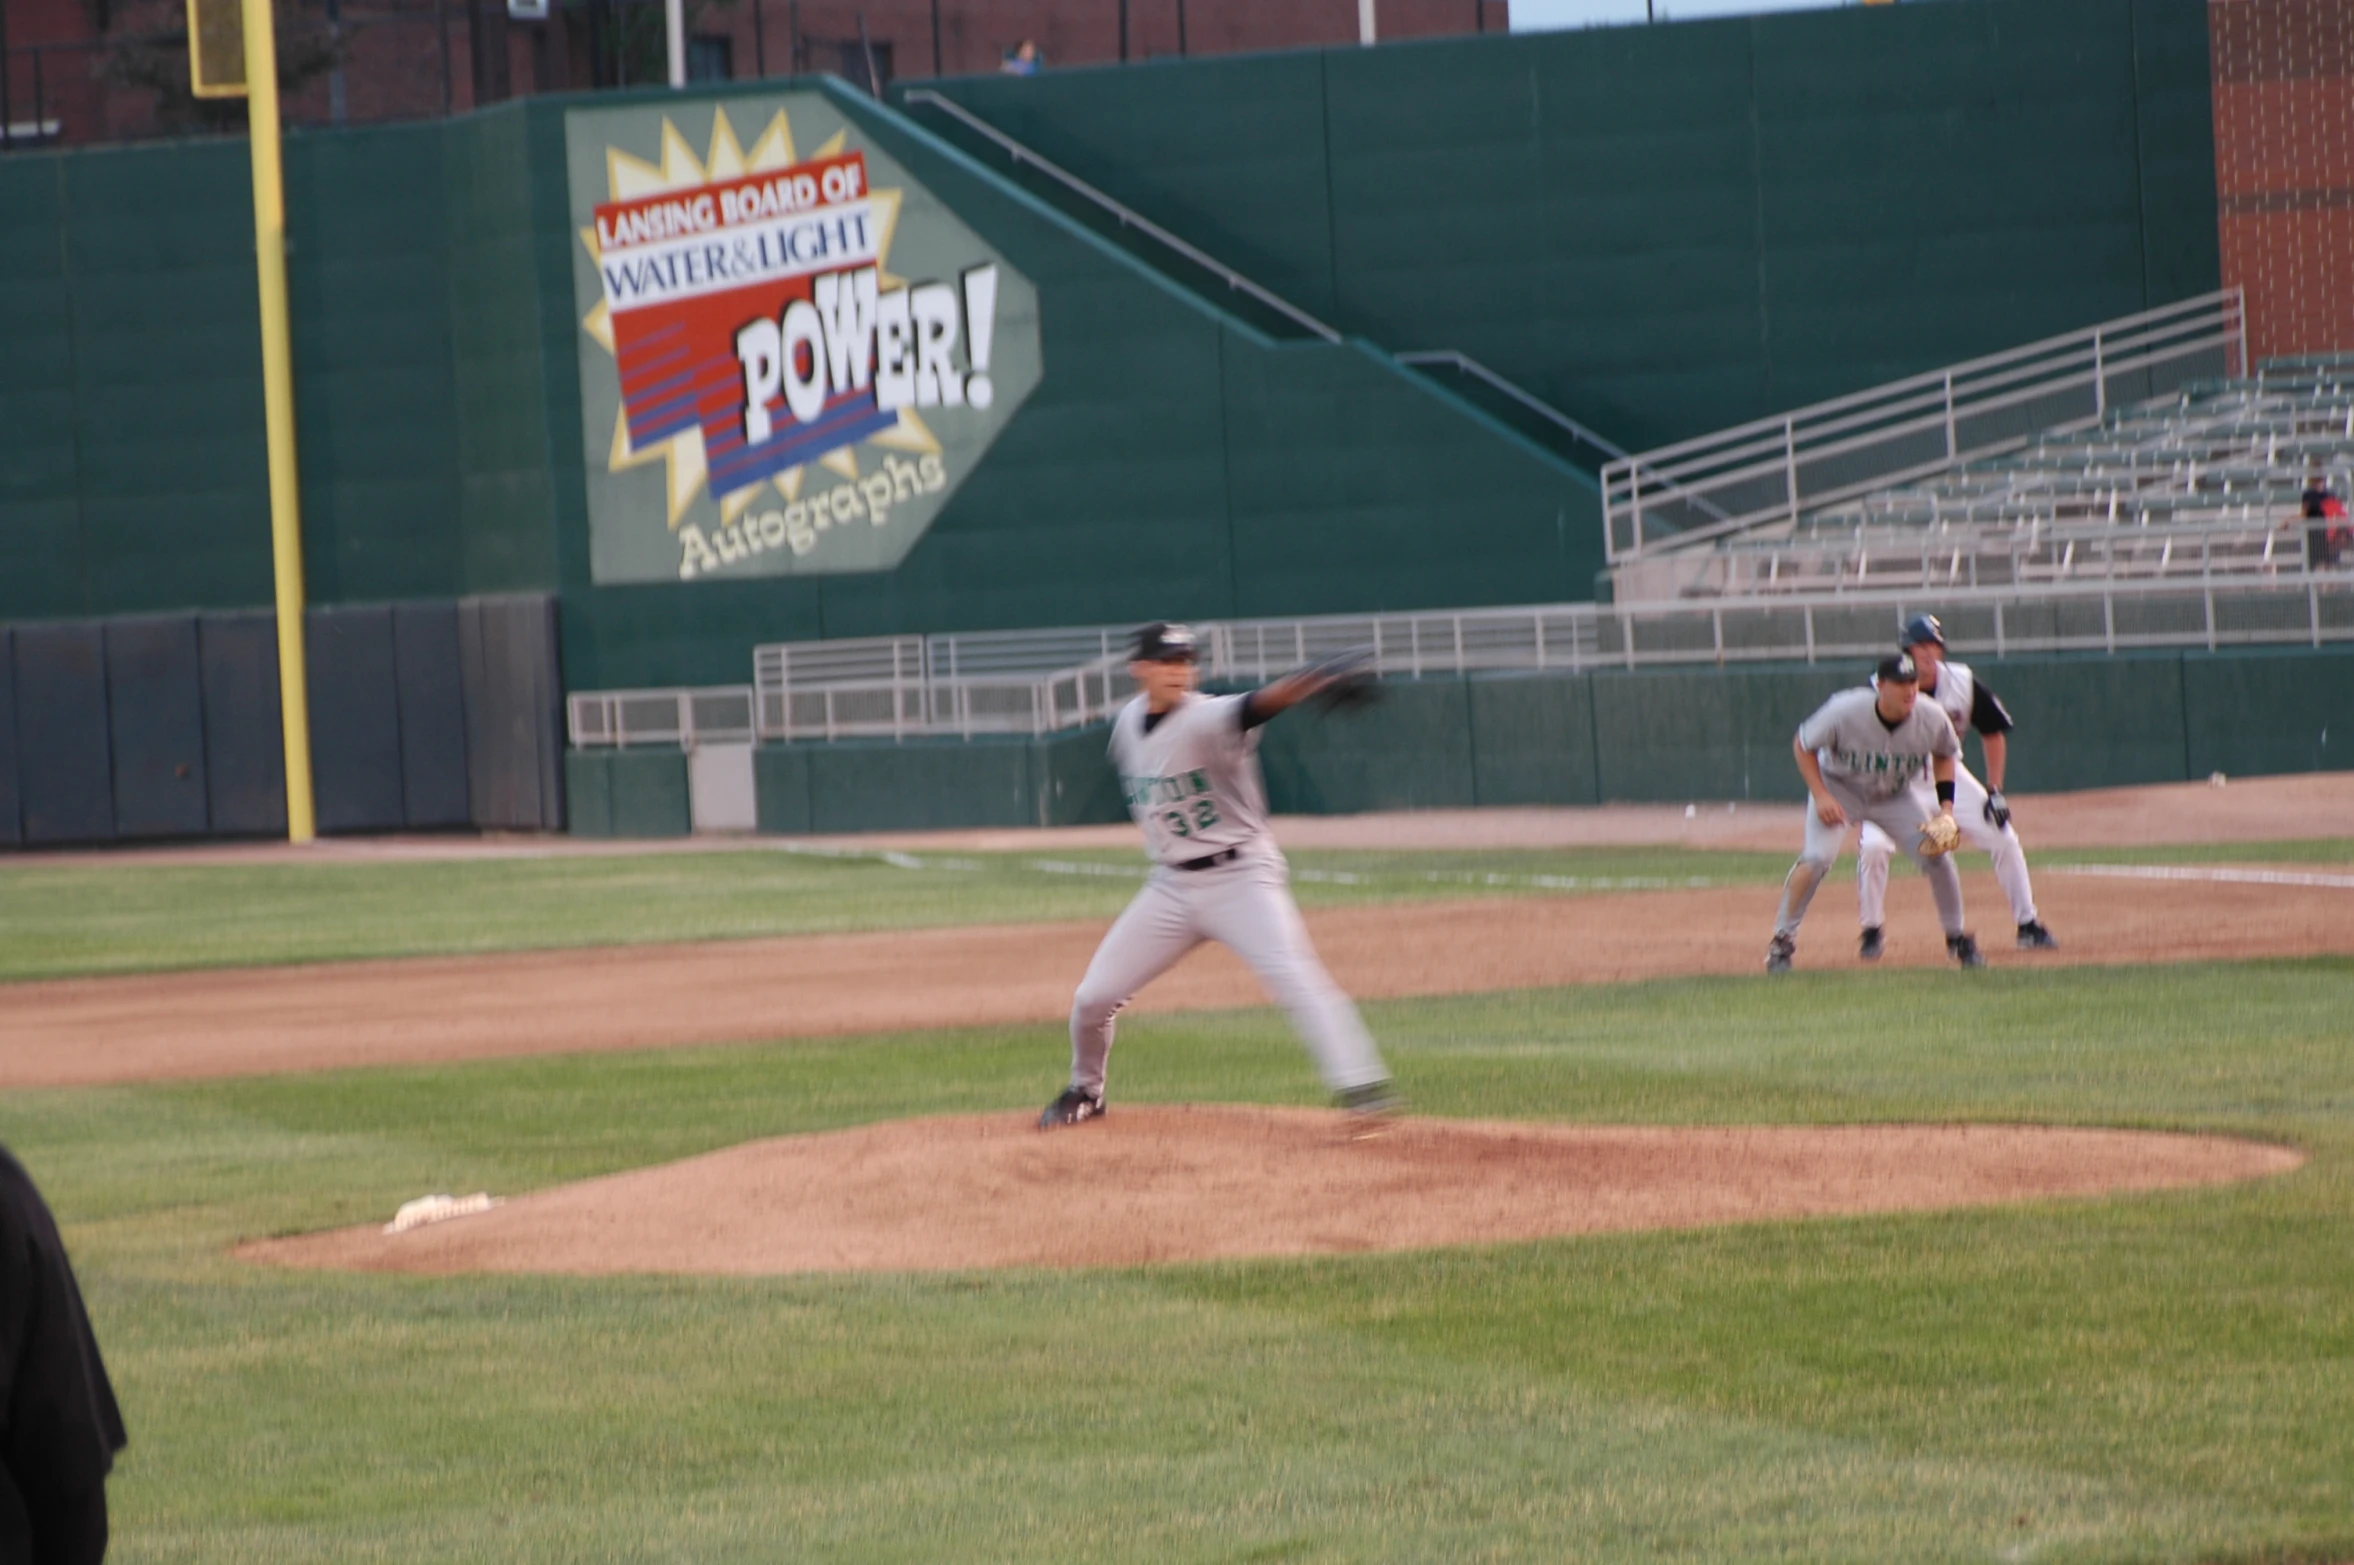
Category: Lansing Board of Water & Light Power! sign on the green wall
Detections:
[{"x1": 565, "y1": 92, "x2": 1040, "y2": 581}]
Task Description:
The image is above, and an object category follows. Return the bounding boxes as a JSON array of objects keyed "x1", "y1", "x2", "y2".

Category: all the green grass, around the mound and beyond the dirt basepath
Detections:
[{"x1": 0, "y1": 845, "x2": 2354, "y2": 1563}]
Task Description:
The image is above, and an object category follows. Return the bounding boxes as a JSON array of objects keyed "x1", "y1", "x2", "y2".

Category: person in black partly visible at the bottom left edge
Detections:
[{"x1": 0, "y1": 1146, "x2": 122, "y2": 1565}]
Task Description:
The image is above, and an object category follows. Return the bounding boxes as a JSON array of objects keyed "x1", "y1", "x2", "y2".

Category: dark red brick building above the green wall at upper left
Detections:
[{"x1": 0, "y1": 0, "x2": 1509, "y2": 146}]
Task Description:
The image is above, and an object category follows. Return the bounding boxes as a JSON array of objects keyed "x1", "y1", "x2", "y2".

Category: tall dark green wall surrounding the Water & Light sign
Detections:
[{"x1": 0, "y1": 0, "x2": 2217, "y2": 696}]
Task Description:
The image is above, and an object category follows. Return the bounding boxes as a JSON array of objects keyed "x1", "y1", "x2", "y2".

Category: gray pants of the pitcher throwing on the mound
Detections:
[{"x1": 1071, "y1": 850, "x2": 1389, "y2": 1094}]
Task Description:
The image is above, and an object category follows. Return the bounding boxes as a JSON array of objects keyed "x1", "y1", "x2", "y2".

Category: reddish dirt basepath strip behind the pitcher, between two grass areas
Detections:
[{"x1": 0, "y1": 859, "x2": 2354, "y2": 1090}]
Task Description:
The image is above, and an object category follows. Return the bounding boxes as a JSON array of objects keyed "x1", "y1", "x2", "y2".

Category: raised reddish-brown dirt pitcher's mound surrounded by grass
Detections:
[{"x1": 238, "y1": 1104, "x2": 2302, "y2": 1276}]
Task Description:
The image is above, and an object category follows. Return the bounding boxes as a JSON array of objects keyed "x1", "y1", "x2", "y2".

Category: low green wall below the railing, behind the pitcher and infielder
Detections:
[{"x1": 570, "y1": 647, "x2": 2354, "y2": 835}]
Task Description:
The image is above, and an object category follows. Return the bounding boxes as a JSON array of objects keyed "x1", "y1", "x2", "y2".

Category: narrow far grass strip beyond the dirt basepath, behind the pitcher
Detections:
[{"x1": 0, "y1": 840, "x2": 2354, "y2": 981}]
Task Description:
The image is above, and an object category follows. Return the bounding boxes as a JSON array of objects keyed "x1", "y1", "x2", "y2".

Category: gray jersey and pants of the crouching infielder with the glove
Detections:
[{"x1": 1773, "y1": 685, "x2": 1963, "y2": 939}]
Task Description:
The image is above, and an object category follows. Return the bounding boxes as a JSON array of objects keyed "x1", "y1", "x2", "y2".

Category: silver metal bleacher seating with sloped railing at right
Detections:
[{"x1": 1612, "y1": 297, "x2": 2354, "y2": 602}]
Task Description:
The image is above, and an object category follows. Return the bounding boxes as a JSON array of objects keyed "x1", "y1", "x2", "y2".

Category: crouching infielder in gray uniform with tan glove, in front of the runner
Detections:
[{"x1": 1766, "y1": 652, "x2": 1987, "y2": 972}]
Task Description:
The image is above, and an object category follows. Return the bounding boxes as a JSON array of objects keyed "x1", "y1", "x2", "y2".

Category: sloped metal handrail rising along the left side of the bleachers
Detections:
[{"x1": 1603, "y1": 289, "x2": 2248, "y2": 565}]
